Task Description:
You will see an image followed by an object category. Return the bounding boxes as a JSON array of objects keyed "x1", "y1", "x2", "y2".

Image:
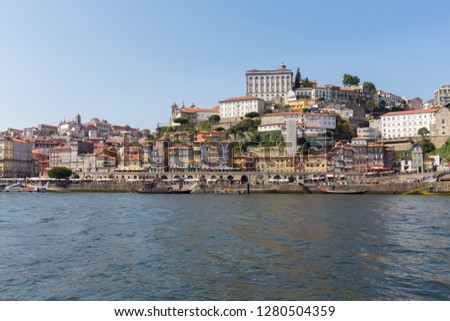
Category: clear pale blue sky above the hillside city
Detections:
[{"x1": 0, "y1": 0, "x2": 450, "y2": 130}]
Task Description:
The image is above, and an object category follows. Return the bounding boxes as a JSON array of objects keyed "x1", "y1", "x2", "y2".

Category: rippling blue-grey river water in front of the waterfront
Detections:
[{"x1": 0, "y1": 193, "x2": 450, "y2": 300}]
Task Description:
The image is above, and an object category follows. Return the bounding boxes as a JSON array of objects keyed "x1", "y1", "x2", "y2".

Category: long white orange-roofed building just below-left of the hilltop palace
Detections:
[{"x1": 219, "y1": 96, "x2": 266, "y2": 121}]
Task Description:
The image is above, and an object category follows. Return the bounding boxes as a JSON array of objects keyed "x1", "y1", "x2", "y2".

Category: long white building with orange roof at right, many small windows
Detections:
[{"x1": 380, "y1": 108, "x2": 439, "y2": 139}]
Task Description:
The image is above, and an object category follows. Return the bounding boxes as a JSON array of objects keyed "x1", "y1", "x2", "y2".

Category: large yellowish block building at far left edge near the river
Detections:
[{"x1": 0, "y1": 138, "x2": 34, "y2": 178}]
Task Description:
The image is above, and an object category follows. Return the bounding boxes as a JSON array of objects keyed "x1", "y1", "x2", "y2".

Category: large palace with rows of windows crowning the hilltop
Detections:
[{"x1": 245, "y1": 63, "x2": 292, "y2": 101}]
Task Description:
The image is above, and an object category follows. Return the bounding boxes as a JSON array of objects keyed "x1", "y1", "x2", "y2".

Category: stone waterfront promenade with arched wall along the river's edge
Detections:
[{"x1": 6, "y1": 172, "x2": 450, "y2": 194}]
